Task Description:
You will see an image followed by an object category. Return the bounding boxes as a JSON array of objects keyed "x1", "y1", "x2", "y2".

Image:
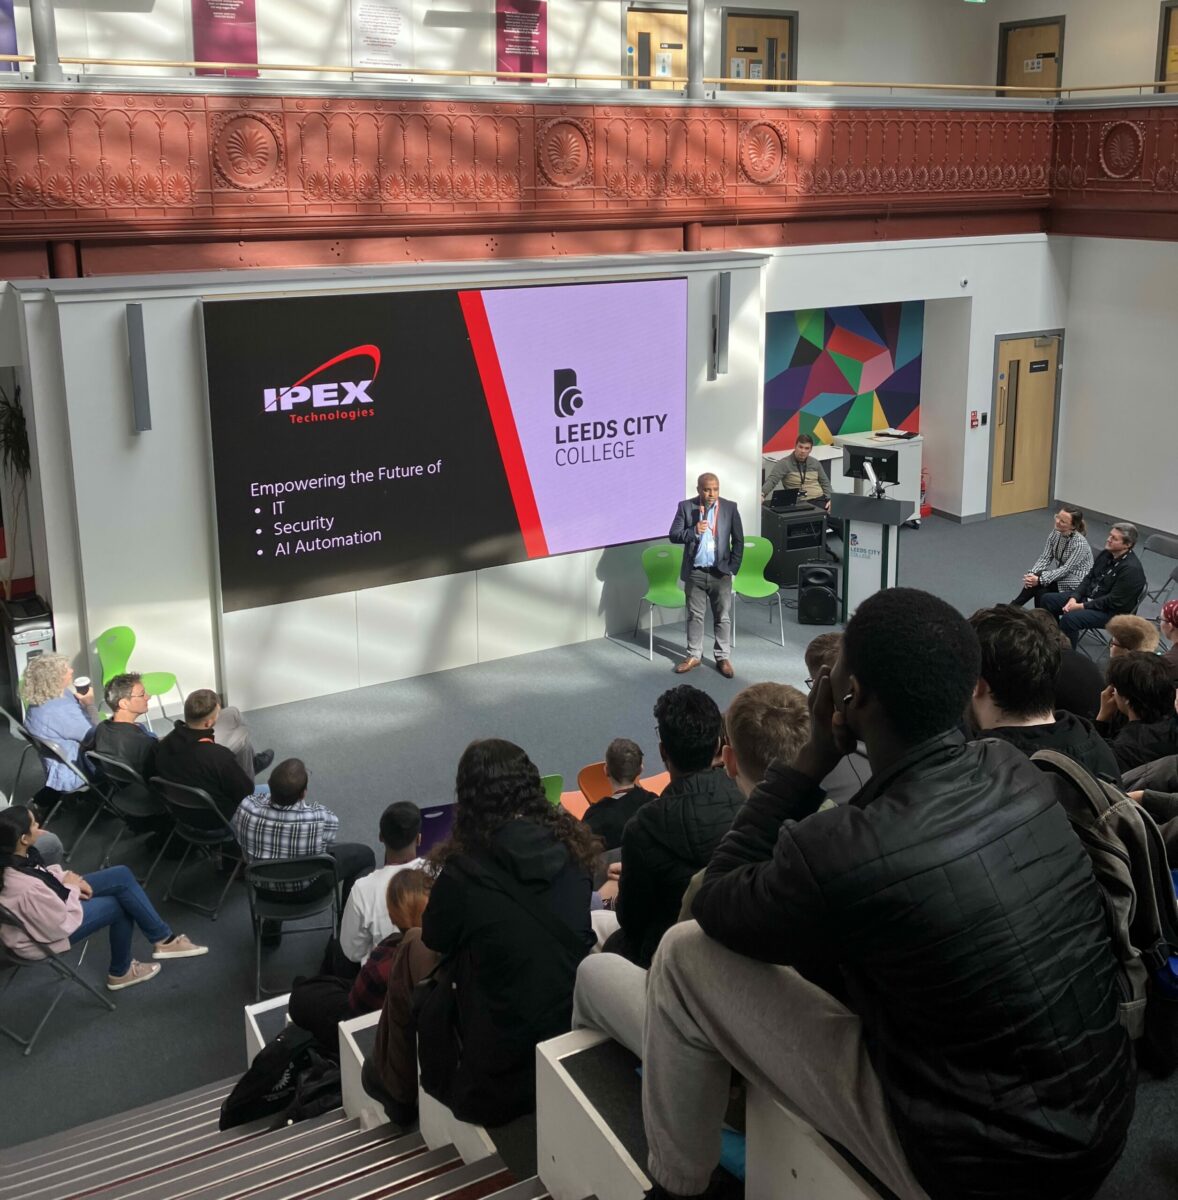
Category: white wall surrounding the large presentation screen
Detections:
[{"x1": 5, "y1": 254, "x2": 764, "y2": 708}]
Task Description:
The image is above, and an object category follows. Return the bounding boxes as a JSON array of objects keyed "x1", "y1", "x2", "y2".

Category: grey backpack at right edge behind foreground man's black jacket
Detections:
[{"x1": 1030, "y1": 750, "x2": 1178, "y2": 1078}]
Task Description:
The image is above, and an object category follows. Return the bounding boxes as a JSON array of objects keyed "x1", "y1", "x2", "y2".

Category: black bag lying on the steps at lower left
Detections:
[{"x1": 221, "y1": 1025, "x2": 342, "y2": 1129}]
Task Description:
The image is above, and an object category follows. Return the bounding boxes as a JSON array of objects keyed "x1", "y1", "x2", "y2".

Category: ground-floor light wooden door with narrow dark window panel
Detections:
[{"x1": 990, "y1": 337, "x2": 1059, "y2": 517}]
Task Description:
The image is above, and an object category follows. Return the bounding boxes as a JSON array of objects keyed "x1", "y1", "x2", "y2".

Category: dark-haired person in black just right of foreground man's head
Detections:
[{"x1": 969, "y1": 604, "x2": 1120, "y2": 787}]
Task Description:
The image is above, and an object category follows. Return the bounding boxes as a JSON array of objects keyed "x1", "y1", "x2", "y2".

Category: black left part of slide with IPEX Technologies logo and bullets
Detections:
[{"x1": 204, "y1": 292, "x2": 527, "y2": 612}]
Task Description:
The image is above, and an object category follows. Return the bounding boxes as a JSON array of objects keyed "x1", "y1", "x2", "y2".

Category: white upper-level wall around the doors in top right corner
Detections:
[{"x1": 976, "y1": 0, "x2": 1161, "y2": 88}]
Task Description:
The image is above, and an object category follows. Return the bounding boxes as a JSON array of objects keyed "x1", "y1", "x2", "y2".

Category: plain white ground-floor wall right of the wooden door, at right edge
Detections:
[{"x1": 1056, "y1": 238, "x2": 1178, "y2": 533}]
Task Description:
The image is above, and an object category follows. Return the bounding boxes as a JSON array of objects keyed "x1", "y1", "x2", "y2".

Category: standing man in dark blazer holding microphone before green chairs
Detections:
[{"x1": 668, "y1": 474, "x2": 745, "y2": 679}]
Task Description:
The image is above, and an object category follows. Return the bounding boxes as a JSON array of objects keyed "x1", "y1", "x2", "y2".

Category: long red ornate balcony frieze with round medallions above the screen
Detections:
[{"x1": 0, "y1": 90, "x2": 1055, "y2": 240}]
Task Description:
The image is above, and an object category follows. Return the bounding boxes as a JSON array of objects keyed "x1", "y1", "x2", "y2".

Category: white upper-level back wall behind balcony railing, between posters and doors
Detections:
[{"x1": 9, "y1": 0, "x2": 998, "y2": 86}]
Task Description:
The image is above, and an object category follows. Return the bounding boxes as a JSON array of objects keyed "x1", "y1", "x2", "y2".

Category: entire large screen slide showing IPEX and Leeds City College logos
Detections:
[{"x1": 203, "y1": 280, "x2": 687, "y2": 612}]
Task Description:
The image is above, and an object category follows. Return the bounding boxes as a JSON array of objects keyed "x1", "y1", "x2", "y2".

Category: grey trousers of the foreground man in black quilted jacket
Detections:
[{"x1": 638, "y1": 920, "x2": 927, "y2": 1200}]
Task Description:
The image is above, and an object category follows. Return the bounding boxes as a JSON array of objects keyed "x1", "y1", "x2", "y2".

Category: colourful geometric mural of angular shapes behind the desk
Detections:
[{"x1": 764, "y1": 300, "x2": 925, "y2": 451}]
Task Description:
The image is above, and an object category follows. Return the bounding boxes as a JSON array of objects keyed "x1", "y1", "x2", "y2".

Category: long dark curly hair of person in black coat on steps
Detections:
[{"x1": 429, "y1": 738, "x2": 601, "y2": 869}]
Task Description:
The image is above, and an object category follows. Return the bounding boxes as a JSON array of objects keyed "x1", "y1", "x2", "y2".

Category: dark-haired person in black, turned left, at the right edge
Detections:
[{"x1": 1096, "y1": 653, "x2": 1178, "y2": 772}]
